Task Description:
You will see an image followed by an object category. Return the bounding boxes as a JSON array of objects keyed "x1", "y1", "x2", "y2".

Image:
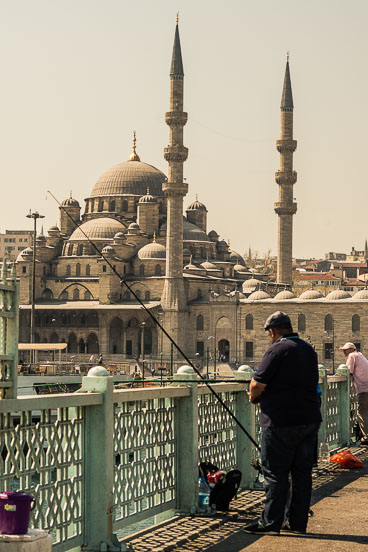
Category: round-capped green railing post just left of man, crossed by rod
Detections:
[{"x1": 234, "y1": 365, "x2": 255, "y2": 489}]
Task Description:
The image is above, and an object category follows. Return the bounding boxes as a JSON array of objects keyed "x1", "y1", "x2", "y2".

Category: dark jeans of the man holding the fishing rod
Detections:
[{"x1": 260, "y1": 423, "x2": 320, "y2": 531}]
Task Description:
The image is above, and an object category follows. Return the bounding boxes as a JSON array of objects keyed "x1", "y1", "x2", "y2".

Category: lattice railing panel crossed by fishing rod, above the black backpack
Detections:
[{"x1": 198, "y1": 392, "x2": 237, "y2": 471}]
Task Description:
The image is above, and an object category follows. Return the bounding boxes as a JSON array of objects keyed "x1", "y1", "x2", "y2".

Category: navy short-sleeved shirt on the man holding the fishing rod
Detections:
[{"x1": 253, "y1": 334, "x2": 322, "y2": 427}]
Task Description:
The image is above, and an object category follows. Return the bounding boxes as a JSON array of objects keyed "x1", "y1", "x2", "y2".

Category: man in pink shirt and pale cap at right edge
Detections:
[{"x1": 340, "y1": 342, "x2": 368, "y2": 446}]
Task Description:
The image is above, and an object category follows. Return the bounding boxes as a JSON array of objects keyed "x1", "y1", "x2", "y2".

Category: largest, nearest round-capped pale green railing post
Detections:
[{"x1": 81, "y1": 366, "x2": 121, "y2": 552}]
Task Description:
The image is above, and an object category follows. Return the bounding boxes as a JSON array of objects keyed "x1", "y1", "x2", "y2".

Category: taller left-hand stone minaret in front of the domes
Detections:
[{"x1": 161, "y1": 18, "x2": 188, "y2": 344}]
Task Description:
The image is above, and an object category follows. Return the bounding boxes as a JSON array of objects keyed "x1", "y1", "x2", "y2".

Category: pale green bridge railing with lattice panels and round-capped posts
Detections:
[{"x1": 0, "y1": 367, "x2": 354, "y2": 552}]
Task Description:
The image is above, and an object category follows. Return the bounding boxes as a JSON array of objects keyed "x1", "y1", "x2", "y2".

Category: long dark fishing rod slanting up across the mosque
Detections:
[{"x1": 47, "y1": 190, "x2": 261, "y2": 451}]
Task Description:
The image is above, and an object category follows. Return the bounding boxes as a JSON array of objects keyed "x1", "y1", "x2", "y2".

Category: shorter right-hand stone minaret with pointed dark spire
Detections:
[{"x1": 274, "y1": 54, "x2": 297, "y2": 284}]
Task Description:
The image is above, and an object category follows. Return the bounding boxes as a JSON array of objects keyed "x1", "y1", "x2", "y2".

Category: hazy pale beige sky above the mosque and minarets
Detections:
[{"x1": 0, "y1": 0, "x2": 368, "y2": 257}]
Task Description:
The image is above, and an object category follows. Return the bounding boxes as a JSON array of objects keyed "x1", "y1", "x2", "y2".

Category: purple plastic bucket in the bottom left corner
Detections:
[{"x1": 0, "y1": 491, "x2": 35, "y2": 535}]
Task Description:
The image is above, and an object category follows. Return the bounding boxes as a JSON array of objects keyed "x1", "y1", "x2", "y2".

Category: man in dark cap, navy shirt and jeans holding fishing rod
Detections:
[{"x1": 244, "y1": 311, "x2": 321, "y2": 535}]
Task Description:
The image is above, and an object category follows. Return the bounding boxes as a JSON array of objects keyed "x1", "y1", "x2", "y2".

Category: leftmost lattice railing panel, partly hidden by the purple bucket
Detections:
[{"x1": 0, "y1": 400, "x2": 84, "y2": 550}]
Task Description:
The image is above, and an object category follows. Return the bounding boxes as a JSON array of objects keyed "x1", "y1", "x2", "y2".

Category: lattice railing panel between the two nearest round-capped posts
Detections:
[{"x1": 113, "y1": 398, "x2": 176, "y2": 527}]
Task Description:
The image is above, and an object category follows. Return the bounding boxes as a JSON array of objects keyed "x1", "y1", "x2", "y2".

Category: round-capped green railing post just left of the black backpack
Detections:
[{"x1": 174, "y1": 366, "x2": 199, "y2": 514}]
